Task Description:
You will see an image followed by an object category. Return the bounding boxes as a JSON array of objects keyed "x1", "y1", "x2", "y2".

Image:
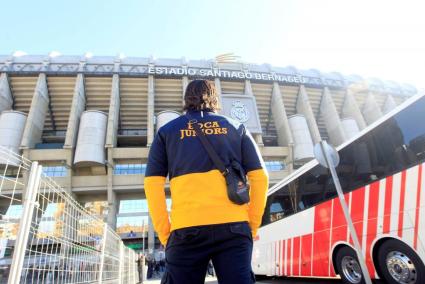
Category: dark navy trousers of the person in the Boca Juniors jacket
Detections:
[{"x1": 161, "y1": 222, "x2": 255, "y2": 284}]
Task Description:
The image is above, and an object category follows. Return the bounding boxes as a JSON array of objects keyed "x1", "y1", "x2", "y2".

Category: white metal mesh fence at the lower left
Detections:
[{"x1": 0, "y1": 147, "x2": 138, "y2": 284}]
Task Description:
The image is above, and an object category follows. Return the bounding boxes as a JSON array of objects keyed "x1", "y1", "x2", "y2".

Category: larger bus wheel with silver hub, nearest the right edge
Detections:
[{"x1": 377, "y1": 239, "x2": 425, "y2": 284}]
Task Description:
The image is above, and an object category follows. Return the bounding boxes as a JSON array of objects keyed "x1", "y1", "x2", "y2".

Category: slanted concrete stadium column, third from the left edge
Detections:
[{"x1": 63, "y1": 74, "x2": 86, "y2": 149}]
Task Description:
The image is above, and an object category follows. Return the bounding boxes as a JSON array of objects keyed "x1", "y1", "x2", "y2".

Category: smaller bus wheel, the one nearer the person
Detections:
[{"x1": 335, "y1": 246, "x2": 365, "y2": 284}]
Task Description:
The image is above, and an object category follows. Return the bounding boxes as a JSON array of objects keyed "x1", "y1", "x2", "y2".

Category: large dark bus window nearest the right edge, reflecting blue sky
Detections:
[{"x1": 337, "y1": 97, "x2": 425, "y2": 192}]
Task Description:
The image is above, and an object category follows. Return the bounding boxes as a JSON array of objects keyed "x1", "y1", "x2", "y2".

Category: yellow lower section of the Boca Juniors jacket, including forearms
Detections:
[{"x1": 145, "y1": 169, "x2": 268, "y2": 244}]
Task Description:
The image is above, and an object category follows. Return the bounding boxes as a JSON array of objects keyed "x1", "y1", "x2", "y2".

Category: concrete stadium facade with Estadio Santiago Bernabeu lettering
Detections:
[{"x1": 0, "y1": 56, "x2": 417, "y2": 252}]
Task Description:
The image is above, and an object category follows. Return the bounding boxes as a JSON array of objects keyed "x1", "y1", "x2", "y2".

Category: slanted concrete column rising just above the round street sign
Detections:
[{"x1": 320, "y1": 87, "x2": 346, "y2": 146}]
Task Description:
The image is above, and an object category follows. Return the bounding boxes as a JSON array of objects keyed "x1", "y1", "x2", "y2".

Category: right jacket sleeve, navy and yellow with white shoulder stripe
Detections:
[{"x1": 242, "y1": 129, "x2": 269, "y2": 237}]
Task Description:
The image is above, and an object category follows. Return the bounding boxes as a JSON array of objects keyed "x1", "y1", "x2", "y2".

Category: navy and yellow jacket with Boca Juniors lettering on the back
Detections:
[{"x1": 144, "y1": 111, "x2": 268, "y2": 245}]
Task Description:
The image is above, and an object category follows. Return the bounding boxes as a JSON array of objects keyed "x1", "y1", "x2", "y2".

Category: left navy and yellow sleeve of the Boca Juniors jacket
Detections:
[{"x1": 144, "y1": 132, "x2": 170, "y2": 246}]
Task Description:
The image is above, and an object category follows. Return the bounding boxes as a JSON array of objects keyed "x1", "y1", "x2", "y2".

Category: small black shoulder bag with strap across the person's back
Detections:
[{"x1": 186, "y1": 114, "x2": 249, "y2": 205}]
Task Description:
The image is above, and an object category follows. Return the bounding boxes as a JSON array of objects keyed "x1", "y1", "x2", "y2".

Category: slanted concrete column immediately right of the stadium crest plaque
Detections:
[{"x1": 271, "y1": 82, "x2": 294, "y2": 146}]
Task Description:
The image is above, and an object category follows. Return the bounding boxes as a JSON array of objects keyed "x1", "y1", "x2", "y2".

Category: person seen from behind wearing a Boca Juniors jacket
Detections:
[{"x1": 144, "y1": 80, "x2": 268, "y2": 284}]
